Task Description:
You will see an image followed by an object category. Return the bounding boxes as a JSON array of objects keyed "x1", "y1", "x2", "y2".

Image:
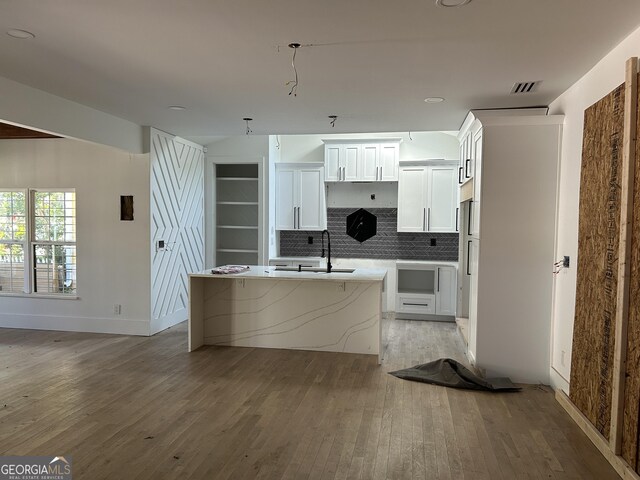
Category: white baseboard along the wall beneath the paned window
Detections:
[{"x1": 0, "y1": 313, "x2": 149, "y2": 336}]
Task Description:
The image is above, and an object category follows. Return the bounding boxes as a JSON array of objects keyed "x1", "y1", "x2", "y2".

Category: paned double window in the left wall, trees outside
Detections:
[{"x1": 0, "y1": 190, "x2": 77, "y2": 295}]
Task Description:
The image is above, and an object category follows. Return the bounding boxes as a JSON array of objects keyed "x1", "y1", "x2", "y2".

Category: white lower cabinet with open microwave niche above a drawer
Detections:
[{"x1": 396, "y1": 260, "x2": 457, "y2": 318}]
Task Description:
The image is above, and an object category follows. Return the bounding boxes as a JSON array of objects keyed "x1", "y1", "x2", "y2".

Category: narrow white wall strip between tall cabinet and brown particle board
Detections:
[{"x1": 550, "y1": 24, "x2": 640, "y2": 392}]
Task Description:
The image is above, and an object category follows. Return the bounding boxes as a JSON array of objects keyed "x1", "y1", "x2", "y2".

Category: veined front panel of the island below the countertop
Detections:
[{"x1": 203, "y1": 278, "x2": 382, "y2": 354}]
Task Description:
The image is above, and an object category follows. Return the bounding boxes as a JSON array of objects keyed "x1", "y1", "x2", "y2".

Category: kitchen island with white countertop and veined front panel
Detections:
[{"x1": 189, "y1": 266, "x2": 387, "y2": 355}]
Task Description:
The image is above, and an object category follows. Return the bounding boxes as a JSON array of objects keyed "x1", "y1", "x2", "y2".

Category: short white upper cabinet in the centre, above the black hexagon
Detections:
[{"x1": 324, "y1": 138, "x2": 400, "y2": 182}]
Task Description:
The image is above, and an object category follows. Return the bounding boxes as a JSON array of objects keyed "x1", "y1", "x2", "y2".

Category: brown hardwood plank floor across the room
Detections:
[{"x1": 0, "y1": 320, "x2": 618, "y2": 480}]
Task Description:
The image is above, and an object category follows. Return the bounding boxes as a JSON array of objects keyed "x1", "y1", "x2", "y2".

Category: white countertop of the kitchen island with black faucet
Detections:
[{"x1": 189, "y1": 265, "x2": 387, "y2": 282}]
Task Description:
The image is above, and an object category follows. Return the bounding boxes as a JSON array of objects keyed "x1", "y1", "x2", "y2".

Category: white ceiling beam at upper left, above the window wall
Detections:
[{"x1": 0, "y1": 77, "x2": 143, "y2": 153}]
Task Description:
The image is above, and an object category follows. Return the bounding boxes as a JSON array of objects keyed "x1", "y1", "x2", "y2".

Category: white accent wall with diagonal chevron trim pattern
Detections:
[{"x1": 149, "y1": 128, "x2": 204, "y2": 334}]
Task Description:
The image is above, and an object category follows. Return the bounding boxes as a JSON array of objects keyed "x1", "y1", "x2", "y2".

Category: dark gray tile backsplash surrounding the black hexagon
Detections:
[{"x1": 280, "y1": 208, "x2": 458, "y2": 261}]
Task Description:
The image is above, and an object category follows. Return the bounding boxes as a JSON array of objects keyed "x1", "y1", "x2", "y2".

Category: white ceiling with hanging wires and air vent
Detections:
[{"x1": 0, "y1": 0, "x2": 640, "y2": 139}]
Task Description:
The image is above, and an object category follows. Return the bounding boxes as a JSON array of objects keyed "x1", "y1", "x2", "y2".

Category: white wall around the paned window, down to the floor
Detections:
[{"x1": 0, "y1": 138, "x2": 150, "y2": 335}]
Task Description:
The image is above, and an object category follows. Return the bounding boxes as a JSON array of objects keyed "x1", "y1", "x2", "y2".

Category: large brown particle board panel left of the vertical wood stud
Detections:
[{"x1": 570, "y1": 81, "x2": 624, "y2": 439}]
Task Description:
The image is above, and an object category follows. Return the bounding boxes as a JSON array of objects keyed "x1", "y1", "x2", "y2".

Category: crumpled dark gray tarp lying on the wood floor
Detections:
[{"x1": 389, "y1": 358, "x2": 522, "y2": 392}]
